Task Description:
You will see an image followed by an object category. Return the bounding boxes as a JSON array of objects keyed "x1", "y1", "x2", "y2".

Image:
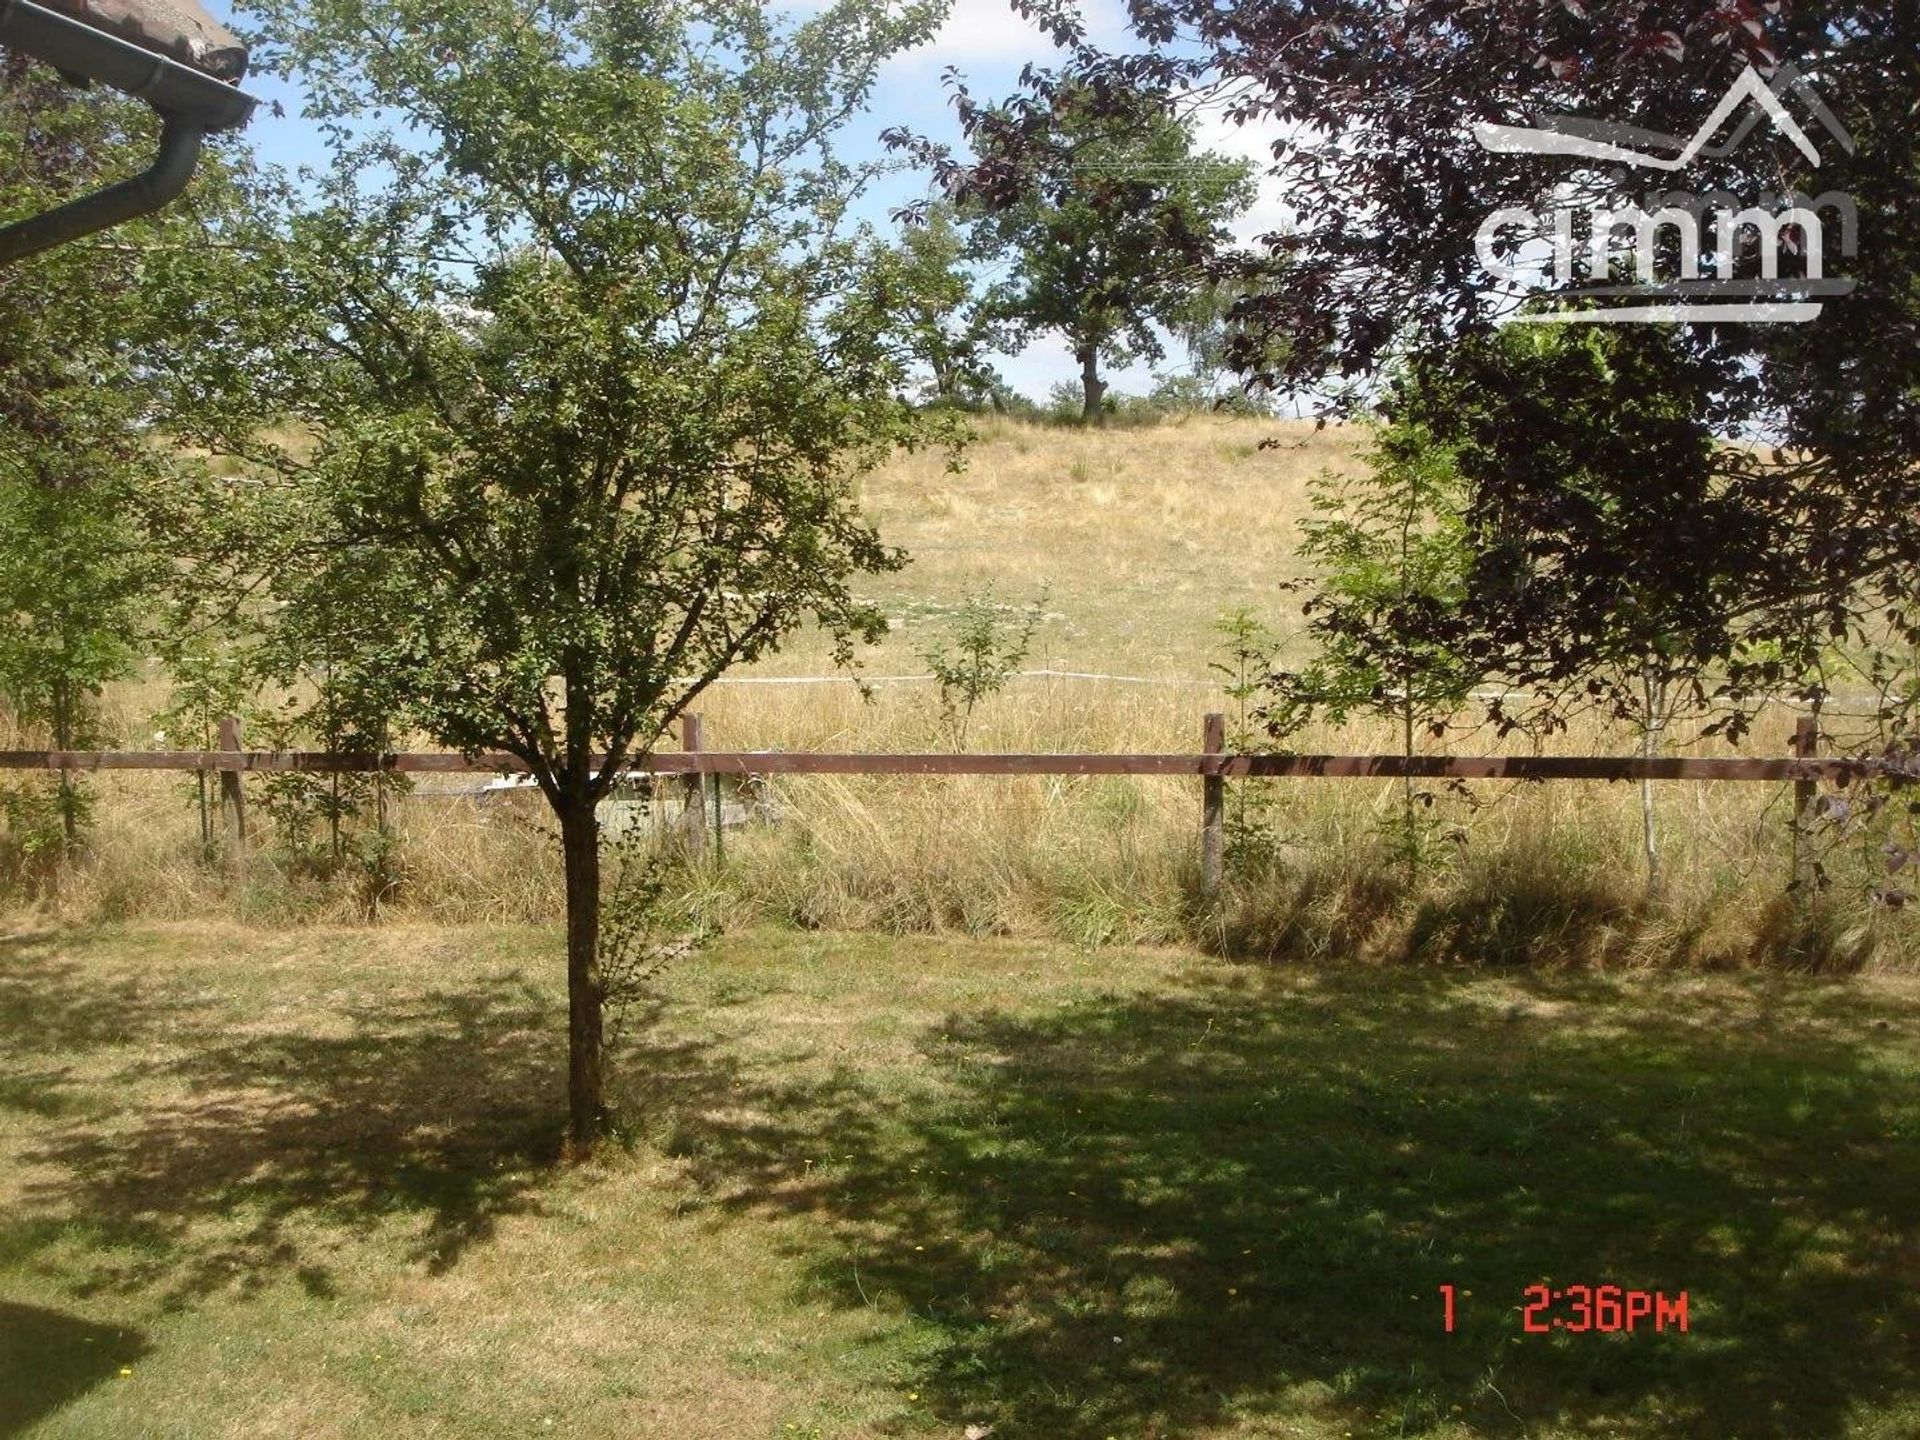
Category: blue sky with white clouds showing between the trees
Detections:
[{"x1": 207, "y1": 0, "x2": 1284, "y2": 399}]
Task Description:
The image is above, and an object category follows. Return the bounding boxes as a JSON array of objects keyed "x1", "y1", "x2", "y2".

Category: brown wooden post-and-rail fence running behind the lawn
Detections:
[{"x1": 0, "y1": 714, "x2": 1881, "y2": 889}]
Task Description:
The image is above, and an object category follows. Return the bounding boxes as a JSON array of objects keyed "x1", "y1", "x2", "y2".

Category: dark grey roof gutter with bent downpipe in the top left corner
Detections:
[{"x1": 0, "y1": 0, "x2": 257, "y2": 265}]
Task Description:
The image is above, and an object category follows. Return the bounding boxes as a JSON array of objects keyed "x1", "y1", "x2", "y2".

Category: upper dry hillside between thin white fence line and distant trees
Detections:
[{"x1": 774, "y1": 417, "x2": 1356, "y2": 678}]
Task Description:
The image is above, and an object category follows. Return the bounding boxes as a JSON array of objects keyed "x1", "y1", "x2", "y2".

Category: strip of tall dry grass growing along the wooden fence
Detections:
[{"x1": 15, "y1": 680, "x2": 1914, "y2": 970}]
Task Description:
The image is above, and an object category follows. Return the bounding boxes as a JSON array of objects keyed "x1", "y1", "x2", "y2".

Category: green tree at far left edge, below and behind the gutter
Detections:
[{"x1": 0, "y1": 54, "x2": 251, "y2": 852}]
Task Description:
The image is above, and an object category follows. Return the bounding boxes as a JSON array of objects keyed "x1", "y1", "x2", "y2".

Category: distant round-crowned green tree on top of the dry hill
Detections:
[{"x1": 964, "y1": 86, "x2": 1254, "y2": 424}]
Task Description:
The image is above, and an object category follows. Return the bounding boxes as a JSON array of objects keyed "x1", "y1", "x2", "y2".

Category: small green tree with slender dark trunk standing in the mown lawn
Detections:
[{"x1": 175, "y1": 0, "x2": 960, "y2": 1154}]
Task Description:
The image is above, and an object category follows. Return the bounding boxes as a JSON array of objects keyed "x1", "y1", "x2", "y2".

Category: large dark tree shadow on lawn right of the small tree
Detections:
[{"x1": 656, "y1": 972, "x2": 1920, "y2": 1440}]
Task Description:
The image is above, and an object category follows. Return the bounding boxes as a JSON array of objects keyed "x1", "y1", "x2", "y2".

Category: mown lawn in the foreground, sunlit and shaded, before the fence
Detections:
[{"x1": 0, "y1": 927, "x2": 1920, "y2": 1440}]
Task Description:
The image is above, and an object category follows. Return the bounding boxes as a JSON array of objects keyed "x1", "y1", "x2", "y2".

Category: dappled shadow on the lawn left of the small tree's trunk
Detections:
[{"x1": 0, "y1": 943, "x2": 583, "y2": 1306}]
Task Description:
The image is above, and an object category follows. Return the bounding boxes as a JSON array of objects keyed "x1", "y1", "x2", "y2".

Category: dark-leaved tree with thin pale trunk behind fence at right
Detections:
[{"x1": 1388, "y1": 324, "x2": 1766, "y2": 895}]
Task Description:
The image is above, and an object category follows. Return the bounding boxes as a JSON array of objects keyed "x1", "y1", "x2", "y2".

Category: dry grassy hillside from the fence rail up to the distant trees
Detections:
[{"x1": 683, "y1": 417, "x2": 1357, "y2": 749}]
